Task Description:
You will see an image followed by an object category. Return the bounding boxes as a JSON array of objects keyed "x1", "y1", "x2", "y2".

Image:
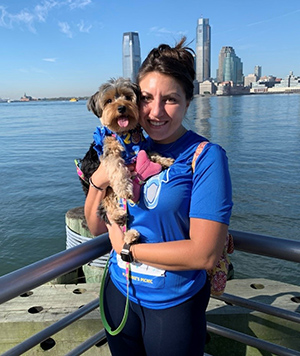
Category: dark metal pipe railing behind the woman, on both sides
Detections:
[{"x1": 0, "y1": 230, "x2": 300, "y2": 356}]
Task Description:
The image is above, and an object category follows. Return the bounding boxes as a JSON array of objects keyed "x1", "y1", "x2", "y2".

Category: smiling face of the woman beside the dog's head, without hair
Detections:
[{"x1": 139, "y1": 72, "x2": 189, "y2": 144}]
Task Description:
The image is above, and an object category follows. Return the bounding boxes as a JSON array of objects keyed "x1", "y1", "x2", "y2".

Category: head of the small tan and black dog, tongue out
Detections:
[{"x1": 87, "y1": 78, "x2": 140, "y2": 133}]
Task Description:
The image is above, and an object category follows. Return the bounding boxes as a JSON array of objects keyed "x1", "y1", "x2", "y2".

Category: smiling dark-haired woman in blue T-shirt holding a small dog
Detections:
[{"x1": 85, "y1": 38, "x2": 232, "y2": 356}]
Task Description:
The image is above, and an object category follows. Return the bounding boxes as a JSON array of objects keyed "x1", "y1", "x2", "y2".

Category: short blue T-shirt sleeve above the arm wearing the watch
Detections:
[{"x1": 190, "y1": 143, "x2": 233, "y2": 225}]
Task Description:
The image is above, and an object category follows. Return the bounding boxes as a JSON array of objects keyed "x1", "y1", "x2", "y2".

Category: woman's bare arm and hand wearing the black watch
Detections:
[{"x1": 108, "y1": 218, "x2": 228, "y2": 271}]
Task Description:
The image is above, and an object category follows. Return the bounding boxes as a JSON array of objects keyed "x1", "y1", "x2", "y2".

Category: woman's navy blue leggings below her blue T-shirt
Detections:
[{"x1": 104, "y1": 277, "x2": 210, "y2": 356}]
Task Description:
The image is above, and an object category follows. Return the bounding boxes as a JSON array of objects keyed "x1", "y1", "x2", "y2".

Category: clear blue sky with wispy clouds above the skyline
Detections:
[{"x1": 0, "y1": 0, "x2": 300, "y2": 99}]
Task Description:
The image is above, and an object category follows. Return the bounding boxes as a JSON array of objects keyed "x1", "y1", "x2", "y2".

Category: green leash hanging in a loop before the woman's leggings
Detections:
[{"x1": 99, "y1": 254, "x2": 130, "y2": 336}]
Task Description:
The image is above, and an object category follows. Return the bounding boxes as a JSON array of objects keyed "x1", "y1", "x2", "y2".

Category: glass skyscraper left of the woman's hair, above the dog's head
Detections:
[{"x1": 123, "y1": 32, "x2": 141, "y2": 82}]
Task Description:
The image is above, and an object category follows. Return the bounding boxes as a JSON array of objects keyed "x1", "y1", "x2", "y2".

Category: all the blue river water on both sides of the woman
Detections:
[{"x1": 0, "y1": 94, "x2": 300, "y2": 285}]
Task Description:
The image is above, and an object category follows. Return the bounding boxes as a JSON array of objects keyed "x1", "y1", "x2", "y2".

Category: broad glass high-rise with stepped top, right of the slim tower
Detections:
[{"x1": 217, "y1": 46, "x2": 243, "y2": 84}]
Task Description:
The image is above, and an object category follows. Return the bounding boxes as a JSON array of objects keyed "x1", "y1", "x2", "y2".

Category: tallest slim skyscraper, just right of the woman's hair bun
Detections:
[{"x1": 196, "y1": 18, "x2": 211, "y2": 83}]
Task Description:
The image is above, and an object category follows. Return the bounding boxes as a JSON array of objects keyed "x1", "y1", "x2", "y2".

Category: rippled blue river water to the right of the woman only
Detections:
[{"x1": 187, "y1": 95, "x2": 300, "y2": 284}]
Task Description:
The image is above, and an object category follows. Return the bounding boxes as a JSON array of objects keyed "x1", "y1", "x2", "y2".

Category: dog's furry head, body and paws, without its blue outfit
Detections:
[{"x1": 81, "y1": 78, "x2": 174, "y2": 243}]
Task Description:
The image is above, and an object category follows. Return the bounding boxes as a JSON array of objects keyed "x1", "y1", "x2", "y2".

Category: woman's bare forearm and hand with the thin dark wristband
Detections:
[{"x1": 84, "y1": 164, "x2": 109, "y2": 236}]
